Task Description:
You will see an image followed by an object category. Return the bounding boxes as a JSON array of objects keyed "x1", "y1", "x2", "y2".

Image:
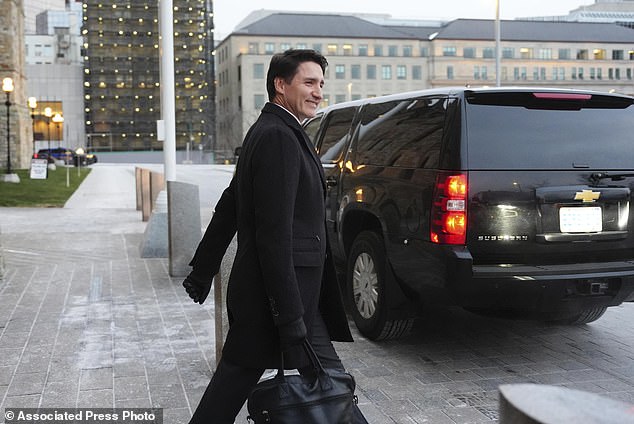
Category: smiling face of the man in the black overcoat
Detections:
[{"x1": 275, "y1": 62, "x2": 324, "y2": 122}]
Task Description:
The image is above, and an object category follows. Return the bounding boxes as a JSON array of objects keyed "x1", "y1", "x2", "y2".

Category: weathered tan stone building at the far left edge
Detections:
[{"x1": 0, "y1": 0, "x2": 33, "y2": 169}]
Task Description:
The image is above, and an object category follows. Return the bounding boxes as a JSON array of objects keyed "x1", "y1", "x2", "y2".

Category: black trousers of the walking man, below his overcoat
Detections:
[{"x1": 189, "y1": 315, "x2": 354, "y2": 424}]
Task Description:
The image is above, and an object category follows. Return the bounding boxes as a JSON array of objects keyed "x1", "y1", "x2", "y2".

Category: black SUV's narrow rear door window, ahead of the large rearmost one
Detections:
[{"x1": 318, "y1": 107, "x2": 357, "y2": 164}]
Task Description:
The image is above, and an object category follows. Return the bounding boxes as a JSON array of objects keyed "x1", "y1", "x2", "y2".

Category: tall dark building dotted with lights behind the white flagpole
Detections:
[{"x1": 82, "y1": 0, "x2": 215, "y2": 151}]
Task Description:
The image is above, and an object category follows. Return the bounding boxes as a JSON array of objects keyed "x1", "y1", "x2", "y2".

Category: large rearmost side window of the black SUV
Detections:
[{"x1": 356, "y1": 98, "x2": 446, "y2": 168}]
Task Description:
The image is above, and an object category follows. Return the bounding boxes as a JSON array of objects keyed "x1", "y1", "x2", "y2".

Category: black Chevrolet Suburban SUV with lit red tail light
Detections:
[{"x1": 305, "y1": 88, "x2": 634, "y2": 340}]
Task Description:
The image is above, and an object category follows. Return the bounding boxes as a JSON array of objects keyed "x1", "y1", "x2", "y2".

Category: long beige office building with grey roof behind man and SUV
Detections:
[{"x1": 216, "y1": 11, "x2": 634, "y2": 151}]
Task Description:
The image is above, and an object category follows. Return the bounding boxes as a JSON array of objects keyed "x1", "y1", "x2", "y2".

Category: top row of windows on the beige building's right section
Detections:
[{"x1": 442, "y1": 46, "x2": 634, "y2": 60}]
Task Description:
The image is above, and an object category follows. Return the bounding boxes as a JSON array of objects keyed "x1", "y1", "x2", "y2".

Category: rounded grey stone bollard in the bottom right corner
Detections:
[{"x1": 499, "y1": 384, "x2": 634, "y2": 424}]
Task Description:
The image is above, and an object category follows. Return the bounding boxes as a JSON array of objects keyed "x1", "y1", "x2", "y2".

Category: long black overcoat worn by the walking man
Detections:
[{"x1": 191, "y1": 103, "x2": 352, "y2": 368}]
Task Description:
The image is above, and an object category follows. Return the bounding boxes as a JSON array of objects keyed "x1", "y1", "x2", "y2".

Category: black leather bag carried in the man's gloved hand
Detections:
[{"x1": 247, "y1": 341, "x2": 356, "y2": 424}]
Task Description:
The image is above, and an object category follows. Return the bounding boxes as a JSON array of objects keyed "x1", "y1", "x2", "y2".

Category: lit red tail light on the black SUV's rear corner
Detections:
[{"x1": 430, "y1": 172, "x2": 467, "y2": 244}]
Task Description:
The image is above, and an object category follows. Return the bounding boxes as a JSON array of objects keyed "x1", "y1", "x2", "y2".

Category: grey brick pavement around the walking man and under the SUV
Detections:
[{"x1": 0, "y1": 164, "x2": 634, "y2": 424}]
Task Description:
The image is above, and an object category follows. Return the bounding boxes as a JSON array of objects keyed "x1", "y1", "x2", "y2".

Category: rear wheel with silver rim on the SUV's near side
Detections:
[{"x1": 346, "y1": 231, "x2": 414, "y2": 341}]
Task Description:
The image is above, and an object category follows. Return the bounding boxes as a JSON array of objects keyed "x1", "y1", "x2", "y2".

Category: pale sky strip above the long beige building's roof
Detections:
[{"x1": 213, "y1": 0, "x2": 595, "y2": 40}]
